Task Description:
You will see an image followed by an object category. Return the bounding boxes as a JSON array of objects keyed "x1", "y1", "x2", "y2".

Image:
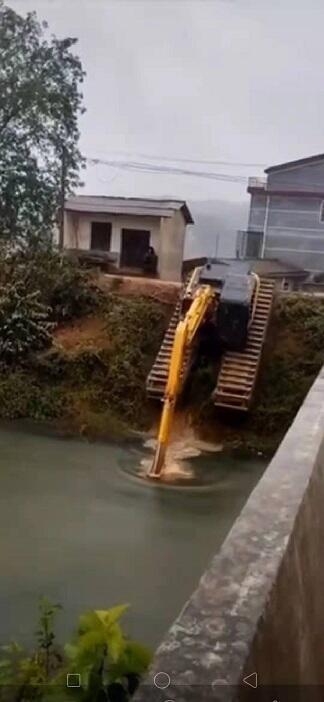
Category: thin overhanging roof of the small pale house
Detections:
[{"x1": 65, "y1": 195, "x2": 194, "y2": 224}]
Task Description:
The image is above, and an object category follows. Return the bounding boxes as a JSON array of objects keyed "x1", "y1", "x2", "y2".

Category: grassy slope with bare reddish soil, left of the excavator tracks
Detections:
[{"x1": 0, "y1": 294, "x2": 169, "y2": 437}]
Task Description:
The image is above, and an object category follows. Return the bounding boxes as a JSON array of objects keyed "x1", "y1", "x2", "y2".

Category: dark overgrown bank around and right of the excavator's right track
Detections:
[{"x1": 188, "y1": 293, "x2": 324, "y2": 454}]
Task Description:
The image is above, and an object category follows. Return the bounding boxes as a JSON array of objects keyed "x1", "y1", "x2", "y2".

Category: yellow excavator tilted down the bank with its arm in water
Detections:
[{"x1": 147, "y1": 263, "x2": 273, "y2": 479}]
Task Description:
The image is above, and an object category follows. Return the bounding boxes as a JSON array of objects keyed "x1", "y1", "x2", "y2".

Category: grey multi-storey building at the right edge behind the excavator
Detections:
[{"x1": 237, "y1": 154, "x2": 324, "y2": 278}]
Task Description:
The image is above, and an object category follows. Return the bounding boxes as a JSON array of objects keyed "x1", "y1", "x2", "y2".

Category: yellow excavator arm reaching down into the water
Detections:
[{"x1": 147, "y1": 285, "x2": 216, "y2": 479}]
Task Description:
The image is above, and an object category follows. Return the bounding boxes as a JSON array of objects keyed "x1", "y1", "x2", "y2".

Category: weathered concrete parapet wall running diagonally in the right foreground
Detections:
[{"x1": 135, "y1": 370, "x2": 324, "y2": 702}]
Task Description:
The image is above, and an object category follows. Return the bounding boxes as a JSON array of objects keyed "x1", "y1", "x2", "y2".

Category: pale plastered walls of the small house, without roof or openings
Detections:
[{"x1": 64, "y1": 211, "x2": 186, "y2": 281}]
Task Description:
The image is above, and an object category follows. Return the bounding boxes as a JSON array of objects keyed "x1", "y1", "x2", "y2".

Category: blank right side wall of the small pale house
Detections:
[{"x1": 160, "y1": 211, "x2": 186, "y2": 281}]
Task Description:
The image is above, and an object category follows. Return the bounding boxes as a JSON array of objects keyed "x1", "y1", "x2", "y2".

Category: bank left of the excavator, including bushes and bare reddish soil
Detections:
[{"x1": 0, "y1": 249, "x2": 169, "y2": 438}]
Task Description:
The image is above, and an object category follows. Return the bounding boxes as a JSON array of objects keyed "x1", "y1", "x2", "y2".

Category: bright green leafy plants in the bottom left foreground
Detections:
[{"x1": 0, "y1": 598, "x2": 151, "y2": 702}]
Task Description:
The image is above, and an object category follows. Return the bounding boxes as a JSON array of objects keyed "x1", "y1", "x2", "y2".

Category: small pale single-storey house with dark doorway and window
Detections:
[{"x1": 64, "y1": 195, "x2": 193, "y2": 281}]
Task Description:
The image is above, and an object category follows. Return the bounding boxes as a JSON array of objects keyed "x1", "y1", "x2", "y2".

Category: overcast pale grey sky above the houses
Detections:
[{"x1": 7, "y1": 0, "x2": 324, "y2": 200}]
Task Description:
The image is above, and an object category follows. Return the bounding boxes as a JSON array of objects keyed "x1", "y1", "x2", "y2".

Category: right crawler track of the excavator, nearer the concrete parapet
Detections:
[{"x1": 213, "y1": 278, "x2": 274, "y2": 410}]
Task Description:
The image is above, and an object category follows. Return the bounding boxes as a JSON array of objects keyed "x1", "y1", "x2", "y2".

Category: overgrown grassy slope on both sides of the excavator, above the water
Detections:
[{"x1": 0, "y1": 294, "x2": 324, "y2": 452}]
